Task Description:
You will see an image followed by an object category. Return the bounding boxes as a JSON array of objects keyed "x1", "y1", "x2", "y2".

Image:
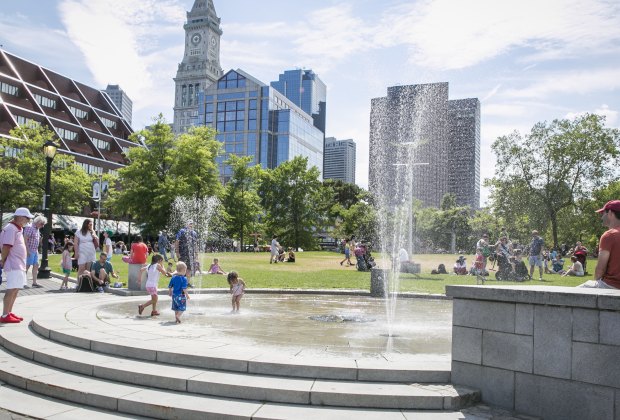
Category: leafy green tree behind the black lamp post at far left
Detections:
[{"x1": 0, "y1": 126, "x2": 93, "y2": 214}]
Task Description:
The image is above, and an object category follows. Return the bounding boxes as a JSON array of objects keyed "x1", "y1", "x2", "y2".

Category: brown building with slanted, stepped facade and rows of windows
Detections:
[{"x1": 0, "y1": 49, "x2": 138, "y2": 174}]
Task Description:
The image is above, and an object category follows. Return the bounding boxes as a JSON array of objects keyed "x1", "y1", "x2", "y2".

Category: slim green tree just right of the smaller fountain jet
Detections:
[{"x1": 222, "y1": 155, "x2": 262, "y2": 250}]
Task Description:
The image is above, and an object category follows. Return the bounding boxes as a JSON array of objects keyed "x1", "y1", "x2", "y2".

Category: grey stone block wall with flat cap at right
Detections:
[{"x1": 447, "y1": 286, "x2": 620, "y2": 420}]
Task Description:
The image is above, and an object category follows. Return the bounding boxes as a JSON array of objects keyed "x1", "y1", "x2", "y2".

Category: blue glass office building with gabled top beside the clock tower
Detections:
[{"x1": 198, "y1": 69, "x2": 323, "y2": 182}]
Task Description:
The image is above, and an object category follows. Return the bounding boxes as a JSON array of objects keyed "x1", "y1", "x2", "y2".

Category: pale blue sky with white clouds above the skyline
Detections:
[{"x1": 0, "y1": 0, "x2": 620, "y2": 203}]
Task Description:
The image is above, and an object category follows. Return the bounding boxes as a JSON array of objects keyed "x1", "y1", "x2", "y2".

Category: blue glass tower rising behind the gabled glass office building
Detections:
[{"x1": 271, "y1": 69, "x2": 327, "y2": 134}]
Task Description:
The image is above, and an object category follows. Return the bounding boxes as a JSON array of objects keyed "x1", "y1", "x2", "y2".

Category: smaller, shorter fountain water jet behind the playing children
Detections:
[{"x1": 169, "y1": 197, "x2": 220, "y2": 314}]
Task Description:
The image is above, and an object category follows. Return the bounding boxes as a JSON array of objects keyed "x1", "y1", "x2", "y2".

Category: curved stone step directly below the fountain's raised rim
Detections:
[{"x1": 0, "y1": 328, "x2": 479, "y2": 410}]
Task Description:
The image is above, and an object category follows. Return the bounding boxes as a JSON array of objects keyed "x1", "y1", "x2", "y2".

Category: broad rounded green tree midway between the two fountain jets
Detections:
[{"x1": 259, "y1": 156, "x2": 329, "y2": 249}]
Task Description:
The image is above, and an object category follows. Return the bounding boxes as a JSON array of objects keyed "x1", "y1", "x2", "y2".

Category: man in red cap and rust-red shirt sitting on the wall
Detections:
[{"x1": 580, "y1": 200, "x2": 620, "y2": 289}]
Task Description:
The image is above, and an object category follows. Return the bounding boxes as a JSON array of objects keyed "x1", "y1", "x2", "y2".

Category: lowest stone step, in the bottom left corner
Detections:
[{"x1": 0, "y1": 382, "x2": 149, "y2": 420}]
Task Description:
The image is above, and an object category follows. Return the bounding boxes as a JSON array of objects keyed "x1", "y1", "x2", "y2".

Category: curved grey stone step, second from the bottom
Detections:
[{"x1": 0, "y1": 348, "x2": 480, "y2": 420}]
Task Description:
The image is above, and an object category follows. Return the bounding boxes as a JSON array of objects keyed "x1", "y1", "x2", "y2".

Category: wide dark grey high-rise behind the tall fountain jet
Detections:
[{"x1": 369, "y1": 83, "x2": 480, "y2": 208}]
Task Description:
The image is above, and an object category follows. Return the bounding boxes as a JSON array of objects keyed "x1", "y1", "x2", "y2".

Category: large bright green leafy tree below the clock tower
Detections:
[{"x1": 110, "y1": 114, "x2": 222, "y2": 232}]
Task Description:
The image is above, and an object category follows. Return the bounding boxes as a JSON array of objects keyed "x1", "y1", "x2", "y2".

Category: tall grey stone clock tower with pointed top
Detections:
[{"x1": 172, "y1": 0, "x2": 222, "y2": 134}]
